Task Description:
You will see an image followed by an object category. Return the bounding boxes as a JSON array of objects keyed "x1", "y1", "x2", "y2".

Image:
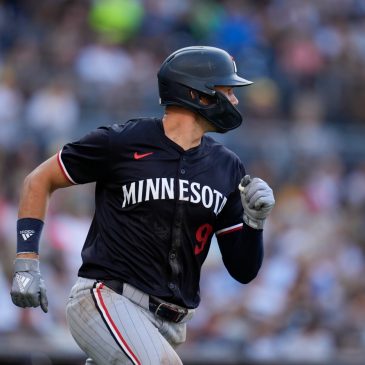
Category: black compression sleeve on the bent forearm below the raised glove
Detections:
[{"x1": 217, "y1": 223, "x2": 264, "y2": 284}]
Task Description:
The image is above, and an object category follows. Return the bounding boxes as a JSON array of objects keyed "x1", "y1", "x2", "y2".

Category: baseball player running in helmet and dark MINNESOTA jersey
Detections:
[{"x1": 11, "y1": 47, "x2": 274, "y2": 365}]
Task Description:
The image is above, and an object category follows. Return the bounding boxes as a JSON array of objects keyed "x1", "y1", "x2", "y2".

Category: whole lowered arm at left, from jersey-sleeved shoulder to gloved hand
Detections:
[{"x1": 11, "y1": 126, "x2": 112, "y2": 312}]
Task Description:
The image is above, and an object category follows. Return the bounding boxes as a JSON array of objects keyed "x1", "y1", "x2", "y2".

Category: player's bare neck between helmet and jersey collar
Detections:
[{"x1": 162, "y1": 107, "x2": 208, "y2": 151}]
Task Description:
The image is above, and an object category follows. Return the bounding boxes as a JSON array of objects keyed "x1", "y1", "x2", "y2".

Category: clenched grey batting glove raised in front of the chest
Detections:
[{"x1": 238, "y1": 175, "x2": 275, "y2": 229}]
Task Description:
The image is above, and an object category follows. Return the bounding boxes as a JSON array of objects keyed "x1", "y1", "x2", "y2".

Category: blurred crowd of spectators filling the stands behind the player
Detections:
[{"x1": 0, "y1": 0, "x2": 365, "y2": 363}]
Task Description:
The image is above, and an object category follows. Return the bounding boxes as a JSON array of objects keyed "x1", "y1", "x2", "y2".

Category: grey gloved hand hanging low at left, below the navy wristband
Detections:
[{"x1": 10, "y1": 258, "x2": 48, "y2": 313}]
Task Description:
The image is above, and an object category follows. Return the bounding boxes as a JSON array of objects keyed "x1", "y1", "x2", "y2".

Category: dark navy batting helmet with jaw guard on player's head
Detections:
[{"x1": 157, "y1": 46, "x2": 252, "y2": 133}]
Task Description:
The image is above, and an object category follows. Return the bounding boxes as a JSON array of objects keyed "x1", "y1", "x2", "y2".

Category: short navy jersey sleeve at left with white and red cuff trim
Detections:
[{"x1": 58, "y1": 127, "x2": 110, "y2": 184}]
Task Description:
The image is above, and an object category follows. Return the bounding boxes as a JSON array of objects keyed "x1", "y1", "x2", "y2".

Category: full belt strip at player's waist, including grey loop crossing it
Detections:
[{"x1": 102, "y1": 280, "x2": 189, "y2": 323}]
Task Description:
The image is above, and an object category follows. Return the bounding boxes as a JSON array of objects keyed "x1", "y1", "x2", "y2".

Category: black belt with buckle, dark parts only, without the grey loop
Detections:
[{"x1": 103, "y1": 280, "x2": 189, "y2": 323}]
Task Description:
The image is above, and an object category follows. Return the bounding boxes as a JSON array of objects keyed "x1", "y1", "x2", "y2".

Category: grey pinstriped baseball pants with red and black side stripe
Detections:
[{"x1": 66, "y1": 278, "x2": 194, "y2": 365}]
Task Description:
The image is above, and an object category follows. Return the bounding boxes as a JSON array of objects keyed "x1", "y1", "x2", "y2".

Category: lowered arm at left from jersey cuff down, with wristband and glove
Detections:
[{"x1": 10, "y1": 155, "x2": 73, "y2": 312}]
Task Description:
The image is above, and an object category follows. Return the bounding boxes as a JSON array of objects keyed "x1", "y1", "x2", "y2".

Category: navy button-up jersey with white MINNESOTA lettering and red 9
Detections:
[{"x1": 59, "y1": 118, "x2": 250, "y2": 308}]
